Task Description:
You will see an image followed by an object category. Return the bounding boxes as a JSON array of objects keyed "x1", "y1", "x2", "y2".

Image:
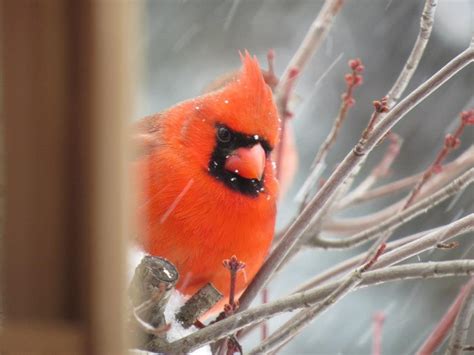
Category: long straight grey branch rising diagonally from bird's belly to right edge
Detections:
[{"x1": 239, "y1": 47, "x2": 474, "y2": 310}]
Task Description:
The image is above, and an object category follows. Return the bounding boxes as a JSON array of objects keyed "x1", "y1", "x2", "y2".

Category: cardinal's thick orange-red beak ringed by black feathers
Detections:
[{"x1": 225, "y1": 143, "x2": 266, "y2": 180}]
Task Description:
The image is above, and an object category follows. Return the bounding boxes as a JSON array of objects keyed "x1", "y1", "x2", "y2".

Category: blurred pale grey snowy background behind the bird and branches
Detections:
[{"x1": 139, "y1": 0, "x2": 474, "y2": 354}]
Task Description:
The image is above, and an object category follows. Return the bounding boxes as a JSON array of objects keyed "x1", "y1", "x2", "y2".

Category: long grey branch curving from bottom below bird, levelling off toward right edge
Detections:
[{"x1": 165, "y1": 260, "x2": 474, "y2": 353}]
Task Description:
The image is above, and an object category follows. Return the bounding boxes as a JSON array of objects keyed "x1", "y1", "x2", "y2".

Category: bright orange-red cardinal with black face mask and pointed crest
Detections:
[{"x1": 136, "y1": 53, "x2": 279, "y2": 304}]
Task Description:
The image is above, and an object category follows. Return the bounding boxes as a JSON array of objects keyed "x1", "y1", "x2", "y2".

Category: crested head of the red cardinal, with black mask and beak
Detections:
[{"x1": 172, "y1": 52, "x2": 279, "y2": 197}]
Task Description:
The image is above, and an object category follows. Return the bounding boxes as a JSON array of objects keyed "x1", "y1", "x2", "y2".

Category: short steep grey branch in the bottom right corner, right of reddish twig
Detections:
[{"x1": 446, "y1": 278, "x2": 474, "y2": 355}]
